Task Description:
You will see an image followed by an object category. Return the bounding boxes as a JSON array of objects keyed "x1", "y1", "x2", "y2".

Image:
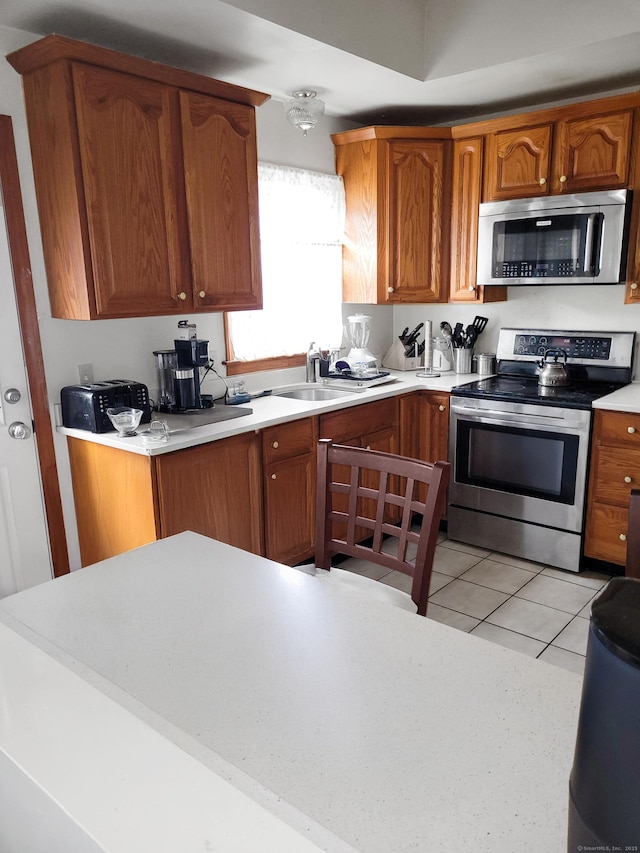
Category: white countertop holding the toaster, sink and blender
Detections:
[{"x1": 58, "y1": 371, "x2": 484, "y2": 456}]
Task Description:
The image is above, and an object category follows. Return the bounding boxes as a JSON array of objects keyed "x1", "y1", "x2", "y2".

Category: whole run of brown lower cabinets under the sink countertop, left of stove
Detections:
[{"x1": 68, "y1": 392, "x2": 449, "y2": 566}]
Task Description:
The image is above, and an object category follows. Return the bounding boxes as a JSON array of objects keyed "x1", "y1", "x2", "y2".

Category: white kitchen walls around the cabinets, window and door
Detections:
[{"x1": 0, "y1": 27, "x2": 640, "y2": 567}]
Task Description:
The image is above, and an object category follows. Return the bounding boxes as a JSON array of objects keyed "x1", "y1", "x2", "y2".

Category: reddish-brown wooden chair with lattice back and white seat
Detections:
[{"x1": 315, "y1": 438, "x2": 449, "y2": 616}]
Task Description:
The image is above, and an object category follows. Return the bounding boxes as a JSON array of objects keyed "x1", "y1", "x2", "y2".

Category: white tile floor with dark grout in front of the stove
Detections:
[{"x1": 340, "y1": 534, "x2": 609, "y2": 673}]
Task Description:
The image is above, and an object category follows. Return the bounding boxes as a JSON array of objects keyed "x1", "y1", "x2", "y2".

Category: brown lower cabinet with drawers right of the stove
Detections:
[{"x1": 584, "y1": 409, "x2": 640, "y2": 566}]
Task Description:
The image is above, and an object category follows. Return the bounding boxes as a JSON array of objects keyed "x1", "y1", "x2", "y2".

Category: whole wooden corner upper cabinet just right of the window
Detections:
[{"x1": 331, "y1": 127, "x2": 451, "y2": 305}]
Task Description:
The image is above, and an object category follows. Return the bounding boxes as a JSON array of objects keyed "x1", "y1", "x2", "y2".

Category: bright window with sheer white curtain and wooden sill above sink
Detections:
[{"x1": 225, "y1": 163, "x2": 344, "y2": 374}]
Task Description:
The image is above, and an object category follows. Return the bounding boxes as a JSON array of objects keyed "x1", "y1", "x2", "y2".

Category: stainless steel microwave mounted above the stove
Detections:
[{"x1": 477, "y1": 190, "x2": 630, "y2": 285}]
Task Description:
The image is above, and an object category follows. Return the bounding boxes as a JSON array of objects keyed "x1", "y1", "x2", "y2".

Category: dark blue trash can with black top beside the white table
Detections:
[{"x1": 567, "y1": 578, "x2": 640, "y2": 853}]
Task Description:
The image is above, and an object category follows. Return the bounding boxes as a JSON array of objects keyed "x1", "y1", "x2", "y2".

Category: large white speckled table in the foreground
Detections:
[{"x1": 0, "y1": 533, "x2": 581, "y2": 853}]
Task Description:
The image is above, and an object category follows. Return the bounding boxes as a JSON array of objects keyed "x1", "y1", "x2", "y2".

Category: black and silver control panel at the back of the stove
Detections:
[{"x1": 496, "y1": 328, "x2": 635, "y2": 368}]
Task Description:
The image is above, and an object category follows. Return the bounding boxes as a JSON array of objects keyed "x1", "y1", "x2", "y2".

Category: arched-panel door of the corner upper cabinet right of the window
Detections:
[{"x1": 387, "y1": 140, "x2": 449, "y2": 303}]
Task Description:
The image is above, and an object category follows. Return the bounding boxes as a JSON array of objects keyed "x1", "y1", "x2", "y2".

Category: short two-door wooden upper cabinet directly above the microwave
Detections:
[{"x1": 484, "y1": 104, "x2": 633, "y2": 201}]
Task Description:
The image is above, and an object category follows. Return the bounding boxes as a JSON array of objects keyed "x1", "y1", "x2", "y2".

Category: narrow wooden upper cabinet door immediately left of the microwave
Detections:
[{"x1": 449, "y1": 136, "x2": 507, "y2": 302}]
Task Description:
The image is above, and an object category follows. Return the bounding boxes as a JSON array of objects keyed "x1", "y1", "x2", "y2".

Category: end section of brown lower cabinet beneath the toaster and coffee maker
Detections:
[{"x1": 68, "y1": 432, "x2": 264, "y2": 566}]
